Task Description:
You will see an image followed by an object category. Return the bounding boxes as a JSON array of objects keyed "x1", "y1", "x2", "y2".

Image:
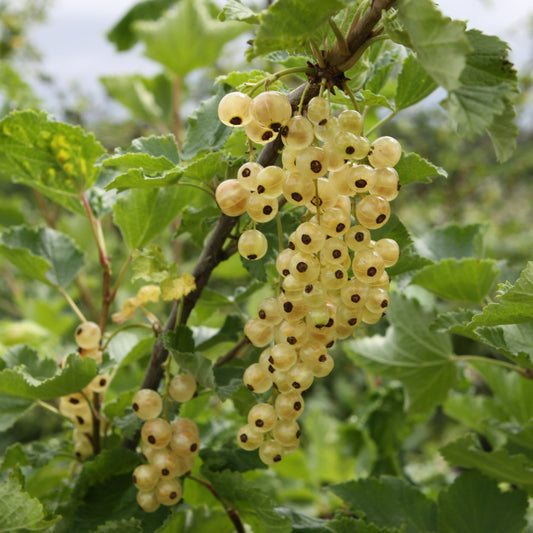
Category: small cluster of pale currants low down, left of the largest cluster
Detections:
[{"x1": 132, "y1": 373, "x2": 200, "y2": 513}]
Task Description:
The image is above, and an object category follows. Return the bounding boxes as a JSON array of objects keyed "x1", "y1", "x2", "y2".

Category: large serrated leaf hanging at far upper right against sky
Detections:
[{"x1": 442, "y1": 30, "x2": 518, "y2": 155}]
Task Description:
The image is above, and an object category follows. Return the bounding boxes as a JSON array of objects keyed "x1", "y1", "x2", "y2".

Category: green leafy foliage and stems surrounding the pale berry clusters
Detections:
[{"x1": 0, "y1": 0, "x2": 533, "y2": 533}]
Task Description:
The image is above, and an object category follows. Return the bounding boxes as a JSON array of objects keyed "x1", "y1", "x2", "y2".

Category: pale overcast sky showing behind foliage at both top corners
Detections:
[{"x1": 31, "y1": 0, "x2": 533, "y2": 117}]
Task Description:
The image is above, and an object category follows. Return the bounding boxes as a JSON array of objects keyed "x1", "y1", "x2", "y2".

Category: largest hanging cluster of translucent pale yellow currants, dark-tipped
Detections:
[{"x1": 216, "y1": 91, "x2": 401, "y2": 464}]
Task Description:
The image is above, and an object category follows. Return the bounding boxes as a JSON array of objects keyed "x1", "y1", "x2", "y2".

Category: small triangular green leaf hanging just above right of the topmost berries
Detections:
[{"x1": 394, "y1": 54, "x2": 438, "y2": 109}]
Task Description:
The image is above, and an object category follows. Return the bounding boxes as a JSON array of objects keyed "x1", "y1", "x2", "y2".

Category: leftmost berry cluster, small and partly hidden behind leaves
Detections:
[{"x1": 59, "y1": 322, "x2": 110, "y2": 459}]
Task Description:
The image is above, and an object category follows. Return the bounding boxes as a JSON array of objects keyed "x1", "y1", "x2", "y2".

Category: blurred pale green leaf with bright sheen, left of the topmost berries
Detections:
[{"x1": 100, "y1": 74, "x2": 172, "y2": 124}]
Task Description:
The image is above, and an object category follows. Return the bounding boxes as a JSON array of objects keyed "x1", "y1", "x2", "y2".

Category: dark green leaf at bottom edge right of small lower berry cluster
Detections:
[{"x1": 203, "y1": 469, "x2": 291, "y2": 533}]
